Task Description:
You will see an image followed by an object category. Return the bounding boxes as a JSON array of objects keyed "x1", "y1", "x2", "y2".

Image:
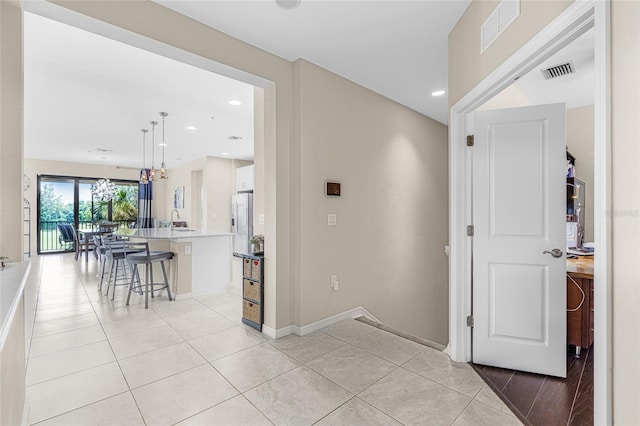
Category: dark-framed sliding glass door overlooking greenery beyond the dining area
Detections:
[{"x1": 37, "y1": 175, "x2": 138, "y2": 254}]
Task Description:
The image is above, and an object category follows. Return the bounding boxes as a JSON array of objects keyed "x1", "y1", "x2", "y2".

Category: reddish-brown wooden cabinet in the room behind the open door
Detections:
[{"x1": 567, "y1": 274, "x2": 594, "y2": 353}]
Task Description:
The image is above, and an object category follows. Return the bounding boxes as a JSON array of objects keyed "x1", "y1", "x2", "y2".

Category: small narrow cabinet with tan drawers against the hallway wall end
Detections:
[{"x1": 242, "y1": 255, "x2": 264, "y2": 331}]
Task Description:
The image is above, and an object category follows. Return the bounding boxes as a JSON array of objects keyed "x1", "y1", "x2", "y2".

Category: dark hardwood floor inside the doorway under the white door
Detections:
[{"x1": 472, "y1": 347, "x2": 593, "y2": 426}]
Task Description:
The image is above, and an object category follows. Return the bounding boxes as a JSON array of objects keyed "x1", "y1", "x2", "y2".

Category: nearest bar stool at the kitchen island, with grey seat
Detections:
[{"x1": 124, "y1": 242, "x2": 174, "y2": 308}]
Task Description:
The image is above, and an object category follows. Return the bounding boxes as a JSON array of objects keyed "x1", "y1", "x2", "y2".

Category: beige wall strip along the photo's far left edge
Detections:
[{"x1": 0, "y1": 1, "x2": 23, "y2": 262}]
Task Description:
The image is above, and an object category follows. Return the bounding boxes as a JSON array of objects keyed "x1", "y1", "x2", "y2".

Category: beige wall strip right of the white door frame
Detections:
[{"x1": 611, "y1": 1, "x2": 640, "y2": 425}]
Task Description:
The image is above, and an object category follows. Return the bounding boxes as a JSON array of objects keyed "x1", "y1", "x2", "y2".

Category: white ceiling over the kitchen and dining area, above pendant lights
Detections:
[{"x1": 24, "y1": 13, "x2": 253, "y2": 168}]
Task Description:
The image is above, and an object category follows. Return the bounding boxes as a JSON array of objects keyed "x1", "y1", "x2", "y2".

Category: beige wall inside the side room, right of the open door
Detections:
[{"x1": 567, "y1": 105, "x2": 593, "y2": 242}]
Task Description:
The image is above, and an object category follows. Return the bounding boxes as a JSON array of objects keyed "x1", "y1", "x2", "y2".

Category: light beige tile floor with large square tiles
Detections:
[{"x1": 25, "y1": 255, "x2": 521, "y2": 426}]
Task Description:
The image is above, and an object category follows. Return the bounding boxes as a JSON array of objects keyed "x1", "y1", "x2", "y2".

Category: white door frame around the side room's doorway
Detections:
[{"x1": 448, "y1": 0, "x2": 612, "y2": 424}]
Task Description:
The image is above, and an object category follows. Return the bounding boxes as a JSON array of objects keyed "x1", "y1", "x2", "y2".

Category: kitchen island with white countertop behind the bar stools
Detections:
[{"x1": 116, "y1": 228, "x2": 233, "y2": 296}]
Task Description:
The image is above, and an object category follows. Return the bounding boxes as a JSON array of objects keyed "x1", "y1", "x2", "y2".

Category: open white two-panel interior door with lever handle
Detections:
[{"x1": 472, "y1": 104, "x2": 567, "y2": 377}]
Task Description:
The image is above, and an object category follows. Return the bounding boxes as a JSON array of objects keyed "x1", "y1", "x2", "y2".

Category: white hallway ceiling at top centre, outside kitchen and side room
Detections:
[{"x1": 154, "y1": 0, "x2": 470, "y2": 123}]
